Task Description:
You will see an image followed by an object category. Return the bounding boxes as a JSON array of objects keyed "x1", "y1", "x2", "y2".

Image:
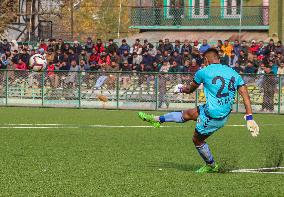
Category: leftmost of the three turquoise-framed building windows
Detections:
[{"x1": 164, "y1": 0, "x2": 185, "y2": 19}]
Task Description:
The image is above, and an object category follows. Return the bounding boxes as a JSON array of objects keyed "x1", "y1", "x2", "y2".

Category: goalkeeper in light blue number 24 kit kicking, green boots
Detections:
[{"x1": 138, "y1": 48, "x2": 259, "y2": 173}]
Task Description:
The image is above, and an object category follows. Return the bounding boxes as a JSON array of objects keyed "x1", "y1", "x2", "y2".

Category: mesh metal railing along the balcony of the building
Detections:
[{"x1": 131, "y1": 6, "x2": 269, "y2": 29}]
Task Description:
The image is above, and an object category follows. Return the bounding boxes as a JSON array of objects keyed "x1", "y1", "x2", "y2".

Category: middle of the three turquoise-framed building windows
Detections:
[{"x1": 189, "y1": 0, "x2": 210, "y2": 18}]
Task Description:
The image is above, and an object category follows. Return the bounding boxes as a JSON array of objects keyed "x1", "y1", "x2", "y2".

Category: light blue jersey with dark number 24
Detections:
[{"x1": 194, "y1": 64, "x2": 245, "y2": 118}]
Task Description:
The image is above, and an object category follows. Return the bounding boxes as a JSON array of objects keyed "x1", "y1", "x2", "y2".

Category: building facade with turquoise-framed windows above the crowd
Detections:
[{"x1": 130, "y1": 0, "x2": 284, "y2": 39}]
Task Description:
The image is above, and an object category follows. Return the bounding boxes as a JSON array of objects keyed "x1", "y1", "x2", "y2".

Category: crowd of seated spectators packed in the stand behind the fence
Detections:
[{"x1": 0, "y1": 38, "x2": 284, "y2": 110}]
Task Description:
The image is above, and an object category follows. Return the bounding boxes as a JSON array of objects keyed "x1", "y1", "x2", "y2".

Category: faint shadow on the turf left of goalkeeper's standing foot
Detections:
[{"x1": 149, "y1": 162, "x2": 200, "y2": 171}]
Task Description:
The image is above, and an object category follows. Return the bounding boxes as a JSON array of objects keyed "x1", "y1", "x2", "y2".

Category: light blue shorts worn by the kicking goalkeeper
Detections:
[{"x1": 195, "y1": 105, "x2": 229, "y2": 136}]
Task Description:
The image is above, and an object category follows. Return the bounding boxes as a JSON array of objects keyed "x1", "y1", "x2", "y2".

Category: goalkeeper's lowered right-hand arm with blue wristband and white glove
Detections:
[{"x1": 239, "y1": 86, "x2": 259, "y2": 137}]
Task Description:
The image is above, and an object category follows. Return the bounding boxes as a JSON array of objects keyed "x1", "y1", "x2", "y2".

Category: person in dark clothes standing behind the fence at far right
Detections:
[{"x1": 262, "y1": 66, "x2": 276, "y2": 112}]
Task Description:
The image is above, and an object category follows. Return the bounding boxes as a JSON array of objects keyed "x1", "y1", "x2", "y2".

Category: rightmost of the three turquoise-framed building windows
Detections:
[{"x1": 221, "y1": 0, "x2": 242, "y2": 18}]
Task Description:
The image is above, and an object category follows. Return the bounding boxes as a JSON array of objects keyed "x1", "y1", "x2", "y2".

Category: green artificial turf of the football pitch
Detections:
[{"x1": 0, "y1": 108, "x2": 284, "y2": 196}]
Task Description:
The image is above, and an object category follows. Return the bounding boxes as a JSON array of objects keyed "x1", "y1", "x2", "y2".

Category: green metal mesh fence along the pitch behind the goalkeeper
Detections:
[{"x1": 0, "y1": 70, "x2": 284, "y2": 113}]
